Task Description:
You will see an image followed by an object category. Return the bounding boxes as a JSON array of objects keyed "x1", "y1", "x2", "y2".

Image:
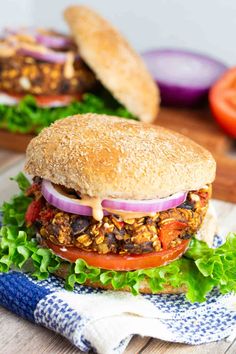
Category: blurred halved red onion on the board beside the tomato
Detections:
[{"x1": 142, "y1": 49, "x2": 227, "y2": 106}]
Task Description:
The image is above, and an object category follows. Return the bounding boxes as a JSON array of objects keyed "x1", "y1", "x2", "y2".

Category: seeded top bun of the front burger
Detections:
[{"x1": 25, "y1": 113, "x2": 216, "y2": 199}]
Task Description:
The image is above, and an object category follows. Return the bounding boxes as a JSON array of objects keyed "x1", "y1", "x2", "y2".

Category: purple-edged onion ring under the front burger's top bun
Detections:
[{"x1": 42, "y1": 180, "x2": 187, "y2": 216}]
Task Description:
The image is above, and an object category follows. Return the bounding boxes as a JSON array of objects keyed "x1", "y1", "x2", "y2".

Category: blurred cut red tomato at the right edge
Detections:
[{"x1": 209, "y1": 67, "x2": 236, "y2": 138}]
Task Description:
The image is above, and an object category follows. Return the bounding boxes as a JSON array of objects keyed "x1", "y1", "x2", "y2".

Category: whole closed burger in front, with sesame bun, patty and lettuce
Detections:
[{"x1": 0, "y1": 114, "x2": 236, "y2": 302}]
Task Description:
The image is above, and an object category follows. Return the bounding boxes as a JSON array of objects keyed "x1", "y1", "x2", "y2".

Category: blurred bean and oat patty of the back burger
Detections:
[{"x1": 0, "y1": 55, "x2": 96, "y2": 95}]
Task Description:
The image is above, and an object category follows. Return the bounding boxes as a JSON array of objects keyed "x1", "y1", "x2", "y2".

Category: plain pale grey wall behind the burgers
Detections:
[{"x1": 0, "y1": 0, "x2": 236, "y2": 65}]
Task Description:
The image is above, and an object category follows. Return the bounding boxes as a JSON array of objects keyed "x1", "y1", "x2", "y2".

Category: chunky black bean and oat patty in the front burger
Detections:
[{"x1": 26, "y1": 177, "x2": 211, "y2": 255}]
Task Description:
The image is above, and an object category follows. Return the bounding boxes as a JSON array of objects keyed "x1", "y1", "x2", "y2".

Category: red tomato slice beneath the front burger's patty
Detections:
[{"x1": 45, "y1": 240, "x2": 190, "y2": 271}]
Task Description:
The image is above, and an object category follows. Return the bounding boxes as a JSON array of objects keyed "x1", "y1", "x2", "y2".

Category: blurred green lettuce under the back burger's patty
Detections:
[{"x1": 0, "y1": 91, "x2": 134, "y2": 133}]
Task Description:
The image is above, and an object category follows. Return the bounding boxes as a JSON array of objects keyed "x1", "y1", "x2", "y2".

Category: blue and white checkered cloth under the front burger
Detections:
[{"x1": 0, "y1": 236, "x2": 236, "y2": 354}]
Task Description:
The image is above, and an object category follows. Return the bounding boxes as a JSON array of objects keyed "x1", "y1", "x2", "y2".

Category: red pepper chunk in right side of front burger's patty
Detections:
[{"x1": 159, "y1": 221, "x2": 187, "y2": 250}]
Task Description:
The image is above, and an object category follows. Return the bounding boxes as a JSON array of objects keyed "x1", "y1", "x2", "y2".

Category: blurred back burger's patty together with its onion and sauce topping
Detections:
[{"x1": 0, "y1": 30, "x2": 96, "y2": 95}]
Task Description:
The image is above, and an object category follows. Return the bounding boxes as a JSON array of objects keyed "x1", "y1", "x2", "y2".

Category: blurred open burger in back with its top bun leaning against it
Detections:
[{"x1": 0, "y1": 6, "x2": 159, "y2": 133}]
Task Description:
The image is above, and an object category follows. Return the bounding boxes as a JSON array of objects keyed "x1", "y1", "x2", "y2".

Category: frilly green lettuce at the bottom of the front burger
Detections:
[{"x1": 0, "y1": 174, "x2": 236, "y2": 302}]
